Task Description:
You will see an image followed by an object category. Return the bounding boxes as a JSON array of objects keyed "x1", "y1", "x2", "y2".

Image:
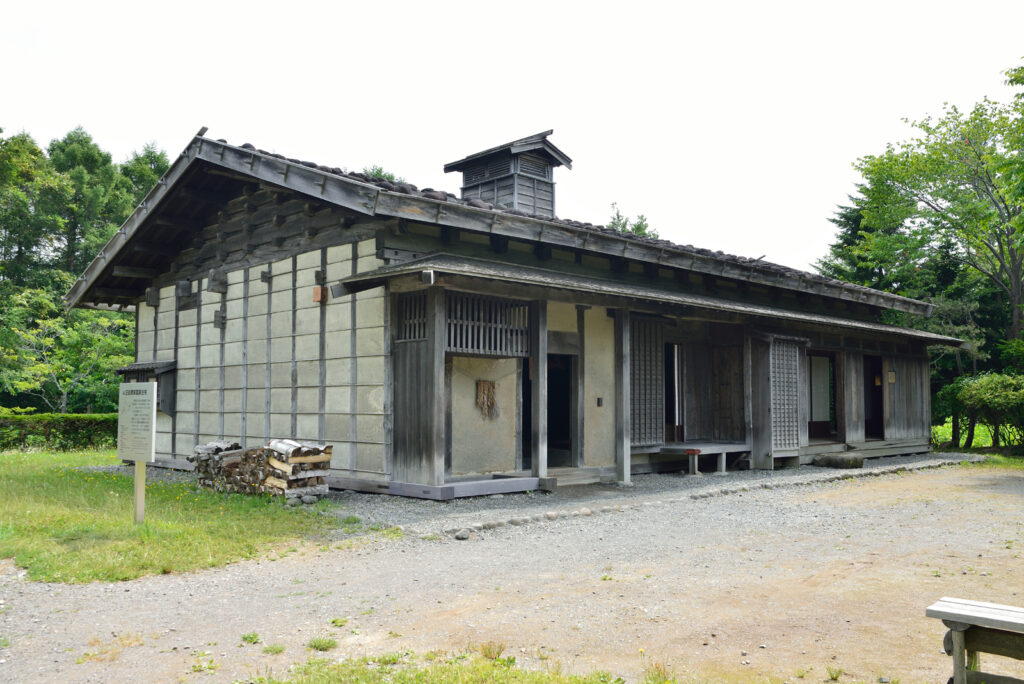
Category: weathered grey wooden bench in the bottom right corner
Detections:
[{"x1": 925, "y1": 597, "x2": 1024, "y2": 684}]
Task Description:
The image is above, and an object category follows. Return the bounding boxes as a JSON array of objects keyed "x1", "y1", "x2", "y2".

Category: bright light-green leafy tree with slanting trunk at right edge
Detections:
[{"x1": 857, "y1": 99, "x2": 1024, "y2": 339}]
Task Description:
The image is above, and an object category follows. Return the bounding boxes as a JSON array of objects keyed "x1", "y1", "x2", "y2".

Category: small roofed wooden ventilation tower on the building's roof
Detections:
[{"x1": 444, "y1": 131, "x2": 572, "y2": 218}]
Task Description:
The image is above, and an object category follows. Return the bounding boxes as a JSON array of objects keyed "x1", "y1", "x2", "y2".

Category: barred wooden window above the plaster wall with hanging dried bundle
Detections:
[{"x1": 445, "y1": 292, "x2": 529, "y2": 356}]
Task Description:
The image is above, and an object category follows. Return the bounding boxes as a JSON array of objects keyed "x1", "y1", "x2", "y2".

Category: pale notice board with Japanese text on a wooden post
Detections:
[{"x1": 118, "y1": 382, "x2": 157, "y2": 524}]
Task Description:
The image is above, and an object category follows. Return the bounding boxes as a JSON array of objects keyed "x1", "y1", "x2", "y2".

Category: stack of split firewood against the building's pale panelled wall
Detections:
[{"x1": 188, "y1": 439, "x2": 333, "y2": 503}]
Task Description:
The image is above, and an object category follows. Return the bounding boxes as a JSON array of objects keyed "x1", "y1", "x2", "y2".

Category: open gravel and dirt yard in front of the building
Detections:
[{"x1": 0, "y1": 467, "x2": 1024, "y2": 683}]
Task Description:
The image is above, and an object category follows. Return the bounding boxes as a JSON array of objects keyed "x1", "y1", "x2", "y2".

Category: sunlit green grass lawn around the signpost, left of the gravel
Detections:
[{"x1": 0, "y1": 450, "x2": 348, "y2": 583}]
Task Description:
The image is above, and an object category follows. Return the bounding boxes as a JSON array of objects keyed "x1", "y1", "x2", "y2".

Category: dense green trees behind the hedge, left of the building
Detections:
[{"x1": 0, "y1": 129, "x2": 163, "y2": 413}]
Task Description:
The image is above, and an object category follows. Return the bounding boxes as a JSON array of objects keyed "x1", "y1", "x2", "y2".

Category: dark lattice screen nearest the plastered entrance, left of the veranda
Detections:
[{"x1": 630, "y1": 318, "x2": 665, "y2": 446}]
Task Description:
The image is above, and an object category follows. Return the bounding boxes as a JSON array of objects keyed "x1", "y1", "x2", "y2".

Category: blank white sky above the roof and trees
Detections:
[{"x1": 0, "y1": 0, "x2": 1024, "y2": 269}]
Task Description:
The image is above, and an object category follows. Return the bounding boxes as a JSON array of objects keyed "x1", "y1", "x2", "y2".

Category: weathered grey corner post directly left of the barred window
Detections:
[{"x1": 422, "y1": 288, "x2": 447, "y2": 485}]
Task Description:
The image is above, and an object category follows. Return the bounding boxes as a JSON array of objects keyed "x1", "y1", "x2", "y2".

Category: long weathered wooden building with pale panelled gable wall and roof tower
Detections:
[{"x1": 67, "y1": 131, "x2": 958, "y2": 499}]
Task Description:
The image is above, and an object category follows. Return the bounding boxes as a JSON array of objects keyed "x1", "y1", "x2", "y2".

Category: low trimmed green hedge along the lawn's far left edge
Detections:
[{"x1": 0, "y1": 414, "x2": 118, "y2": 451}]
